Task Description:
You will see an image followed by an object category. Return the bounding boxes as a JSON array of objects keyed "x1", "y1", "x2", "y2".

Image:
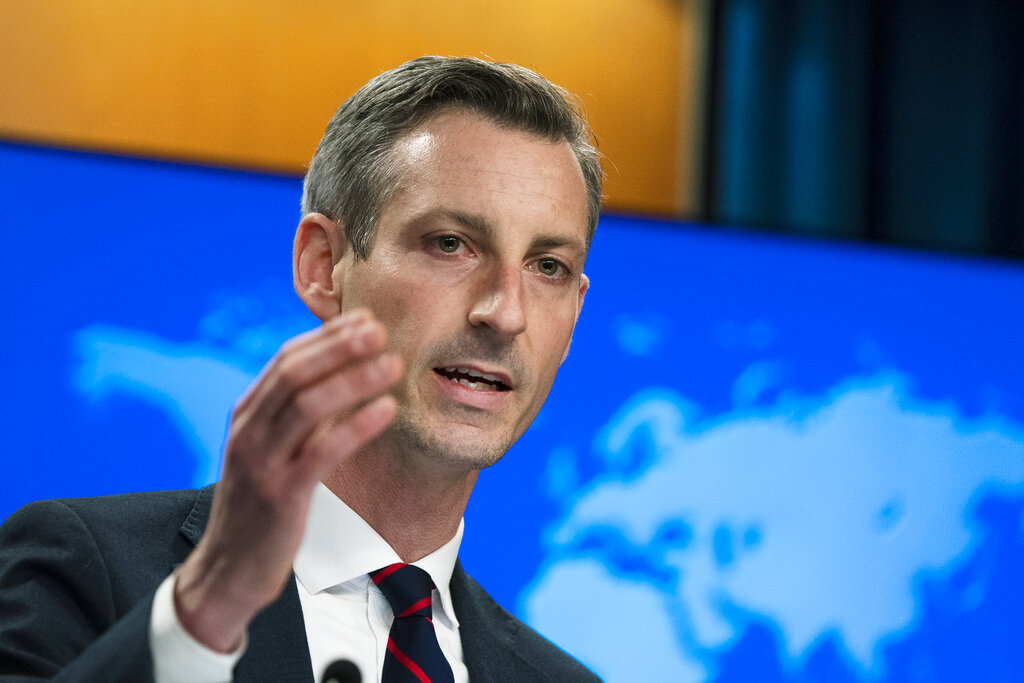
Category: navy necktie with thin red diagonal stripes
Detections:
[{"x1": 370, "y1": 562, "x2": 455, "y2": 683}]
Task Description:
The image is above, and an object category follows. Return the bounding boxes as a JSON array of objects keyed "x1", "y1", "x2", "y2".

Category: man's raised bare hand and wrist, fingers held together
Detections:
[{"x1": 174, "y1": 310, "x2": 401, "y2": 652}]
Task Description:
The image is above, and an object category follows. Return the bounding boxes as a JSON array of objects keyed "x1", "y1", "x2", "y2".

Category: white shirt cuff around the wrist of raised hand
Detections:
[{"x1": 150, "y1": 573, "x2": 248, "y2": 683}]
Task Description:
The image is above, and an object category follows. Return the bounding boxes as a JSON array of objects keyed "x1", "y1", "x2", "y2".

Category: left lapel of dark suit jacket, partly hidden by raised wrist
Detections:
[{"x1": 181, "y1": 486, "x2": 313, "y2": 682}]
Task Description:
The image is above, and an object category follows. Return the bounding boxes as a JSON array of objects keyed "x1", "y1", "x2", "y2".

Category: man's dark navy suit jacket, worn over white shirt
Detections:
[{"x1": 0, "y1": 486, "x2": 599, "y2": 683}]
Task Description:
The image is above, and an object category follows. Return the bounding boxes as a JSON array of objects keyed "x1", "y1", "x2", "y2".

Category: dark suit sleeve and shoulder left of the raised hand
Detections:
[{"x1": 0, "y1": 490, "x2": 198, "y2": 681}]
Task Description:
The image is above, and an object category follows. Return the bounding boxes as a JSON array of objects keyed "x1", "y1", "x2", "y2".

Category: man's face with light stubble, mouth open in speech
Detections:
[{"x1": 334, "y1": 111, "x2": 588, "y2": 468}]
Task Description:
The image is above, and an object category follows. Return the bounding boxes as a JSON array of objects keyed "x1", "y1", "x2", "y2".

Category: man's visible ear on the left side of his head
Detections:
[{"x1": 292, "y1": 213, "x2": 348, "y2": 322}]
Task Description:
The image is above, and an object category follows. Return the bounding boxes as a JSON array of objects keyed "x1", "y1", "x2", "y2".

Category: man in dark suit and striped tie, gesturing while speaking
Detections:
[{"x1": 0, "y1": 57, "x2": 601, "y2": 682}]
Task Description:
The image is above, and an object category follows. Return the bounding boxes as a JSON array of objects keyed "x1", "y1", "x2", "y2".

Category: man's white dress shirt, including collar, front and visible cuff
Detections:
[{"x1": 150, "y1": 484, "x2": 469, "y2": 683}]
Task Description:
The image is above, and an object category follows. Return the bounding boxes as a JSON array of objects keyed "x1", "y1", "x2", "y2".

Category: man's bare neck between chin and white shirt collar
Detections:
[{"x1": 324, "y1": 449, "x2": 478, "y2": 562}]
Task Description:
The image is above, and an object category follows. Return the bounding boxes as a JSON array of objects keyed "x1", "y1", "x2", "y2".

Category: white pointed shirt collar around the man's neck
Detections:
[{"x1": 295, "y1": 483, "x2": 465, "y2": 624}]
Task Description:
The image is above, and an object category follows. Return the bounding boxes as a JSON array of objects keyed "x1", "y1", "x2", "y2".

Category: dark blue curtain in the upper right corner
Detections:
[{"x1": 702, "y1": 0, "x2": 1024, "y2": 258}]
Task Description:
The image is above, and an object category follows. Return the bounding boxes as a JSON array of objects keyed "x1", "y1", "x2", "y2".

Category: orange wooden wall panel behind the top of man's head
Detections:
[{"x1": 0, "y1": 0, "x2": 681, "y2": 213}]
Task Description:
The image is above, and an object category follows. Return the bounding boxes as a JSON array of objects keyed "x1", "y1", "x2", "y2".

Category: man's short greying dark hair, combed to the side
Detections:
[{"x1": 302, "y1": 56, "x2": 603, "y2": 258}]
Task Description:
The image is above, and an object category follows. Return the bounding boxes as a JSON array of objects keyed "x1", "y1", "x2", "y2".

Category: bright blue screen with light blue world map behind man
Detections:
[{"x1": 0, "y1": 144, "x2": 1024, "y2": 681}]
